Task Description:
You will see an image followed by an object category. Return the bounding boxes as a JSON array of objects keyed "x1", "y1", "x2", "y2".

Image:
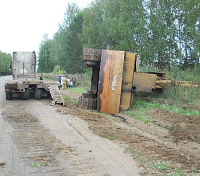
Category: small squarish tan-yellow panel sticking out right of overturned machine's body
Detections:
[{"x1": 133, "y1": 73, "x2": 157, "y2": 92}]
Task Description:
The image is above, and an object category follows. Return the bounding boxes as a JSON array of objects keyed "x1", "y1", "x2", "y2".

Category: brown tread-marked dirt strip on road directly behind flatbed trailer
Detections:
[{"x1": 3, "y1": 101, "x2": 75, "y2": 176}]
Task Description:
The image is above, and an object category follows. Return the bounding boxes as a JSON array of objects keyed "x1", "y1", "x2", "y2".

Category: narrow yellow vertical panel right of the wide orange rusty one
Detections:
[{"x1": 120, "y1": 52, "x2": 136, "y2": 110}]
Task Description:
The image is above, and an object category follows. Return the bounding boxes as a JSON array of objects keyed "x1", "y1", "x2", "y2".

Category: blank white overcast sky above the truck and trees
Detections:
[{"x1": 0, "y1": 0, "x2": 92, "y2": 54}]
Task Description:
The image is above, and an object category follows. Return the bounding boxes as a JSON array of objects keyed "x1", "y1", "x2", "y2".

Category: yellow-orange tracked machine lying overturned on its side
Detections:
[{"x1": 79, "y1": 48, "x2": 169, "y2": 114}]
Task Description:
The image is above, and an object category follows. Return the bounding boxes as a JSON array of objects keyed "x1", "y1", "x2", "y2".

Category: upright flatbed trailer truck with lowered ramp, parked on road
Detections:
[{"x1": 5, "y1": 51, "x2": 64, "y2": 104}]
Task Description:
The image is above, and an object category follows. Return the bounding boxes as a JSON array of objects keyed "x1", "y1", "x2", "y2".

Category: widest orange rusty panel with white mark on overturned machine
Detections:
[{"x1": 97, "y1": 50, "x2": 124, "y2": 114}]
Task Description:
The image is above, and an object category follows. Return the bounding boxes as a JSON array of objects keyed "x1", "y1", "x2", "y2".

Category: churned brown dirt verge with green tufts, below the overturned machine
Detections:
[{"x1": 61, "y1": 89, "x2": 200, "y2": 175}]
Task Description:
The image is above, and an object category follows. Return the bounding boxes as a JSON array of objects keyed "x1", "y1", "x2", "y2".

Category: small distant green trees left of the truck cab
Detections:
[{"x1": 0, "y1": 51, "x2": 12, "y2": 75}]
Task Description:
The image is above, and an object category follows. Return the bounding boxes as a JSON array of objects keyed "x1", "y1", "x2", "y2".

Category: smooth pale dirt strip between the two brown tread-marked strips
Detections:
[{"x1": 29, "y1": 101, "x2": 139, "y2": 176}]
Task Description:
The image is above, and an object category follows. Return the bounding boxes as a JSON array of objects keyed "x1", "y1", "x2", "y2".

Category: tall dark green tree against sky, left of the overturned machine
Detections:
[{"x1": 44, "y1": 4, "x2": 83, "y2": 73}]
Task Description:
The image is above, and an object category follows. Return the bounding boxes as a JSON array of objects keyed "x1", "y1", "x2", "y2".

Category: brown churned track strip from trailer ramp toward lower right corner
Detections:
[{"x1": 59, "y1": 97, "x2": 200, "y2": 175}]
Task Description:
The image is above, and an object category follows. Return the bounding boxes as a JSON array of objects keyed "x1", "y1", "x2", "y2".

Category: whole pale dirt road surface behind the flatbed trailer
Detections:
[{"x1": 0, "y1": 77, "x2": 143, "y2": 176}]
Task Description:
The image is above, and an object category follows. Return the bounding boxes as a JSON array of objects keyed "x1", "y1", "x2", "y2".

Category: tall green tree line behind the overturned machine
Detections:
[{"x1": 38, "y1": 0, "x2": 200, "y2": 73}]
